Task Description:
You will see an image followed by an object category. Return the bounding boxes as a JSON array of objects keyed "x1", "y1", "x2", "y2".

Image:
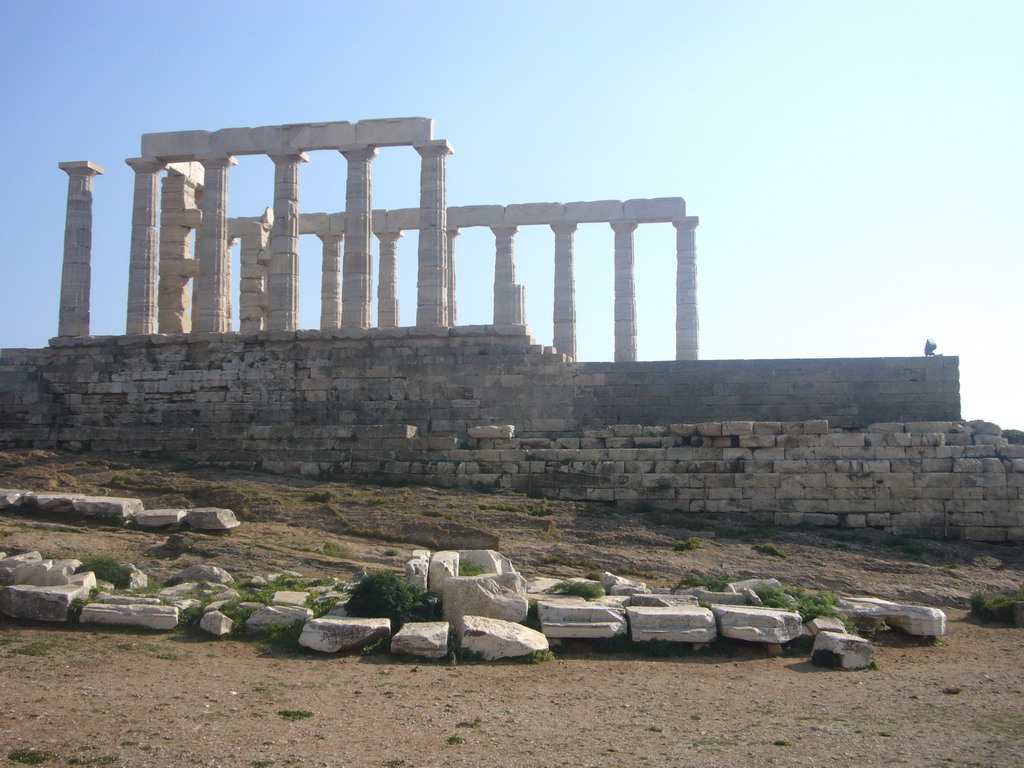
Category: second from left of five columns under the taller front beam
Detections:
[{"x1": 193, "y1": 155, "x2": 234, "y2": 333}]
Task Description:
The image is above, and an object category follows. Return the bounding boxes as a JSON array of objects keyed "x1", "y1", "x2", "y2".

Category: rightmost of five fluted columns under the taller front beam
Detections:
[{"x1": 416, "y1": 139, "x2": 452, "y2": 327}]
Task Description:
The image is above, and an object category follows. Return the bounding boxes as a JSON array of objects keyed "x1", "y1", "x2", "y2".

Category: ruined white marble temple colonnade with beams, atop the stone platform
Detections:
[{"x1": 57, "y1": 118, "x2": 699, "y2": 361}]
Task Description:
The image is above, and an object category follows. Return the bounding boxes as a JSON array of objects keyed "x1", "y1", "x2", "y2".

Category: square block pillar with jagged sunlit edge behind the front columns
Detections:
[{"x1": 157, "y1": 163, "x2": 203, "y2": 334}]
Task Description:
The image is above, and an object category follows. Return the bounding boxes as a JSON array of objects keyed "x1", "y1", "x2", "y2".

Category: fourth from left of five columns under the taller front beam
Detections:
[{"x1": 341, "y1": 146, "x2": 377, "y2": 328}]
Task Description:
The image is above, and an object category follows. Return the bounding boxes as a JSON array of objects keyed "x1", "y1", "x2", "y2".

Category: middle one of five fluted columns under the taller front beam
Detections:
[{"x1": 266, "y1": 153, "x2": 306, "y2": 331}]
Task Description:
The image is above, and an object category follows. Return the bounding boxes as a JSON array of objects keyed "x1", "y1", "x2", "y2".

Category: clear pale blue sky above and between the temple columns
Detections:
[{"x1": 0, "y1": 0, "x2": 1024, "y2": 428}]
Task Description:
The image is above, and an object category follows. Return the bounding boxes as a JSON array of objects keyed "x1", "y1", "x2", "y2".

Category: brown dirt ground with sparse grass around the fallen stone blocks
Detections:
[{"x1": 0, "y1": 452, "x2": 1024, "y2": 768}]
